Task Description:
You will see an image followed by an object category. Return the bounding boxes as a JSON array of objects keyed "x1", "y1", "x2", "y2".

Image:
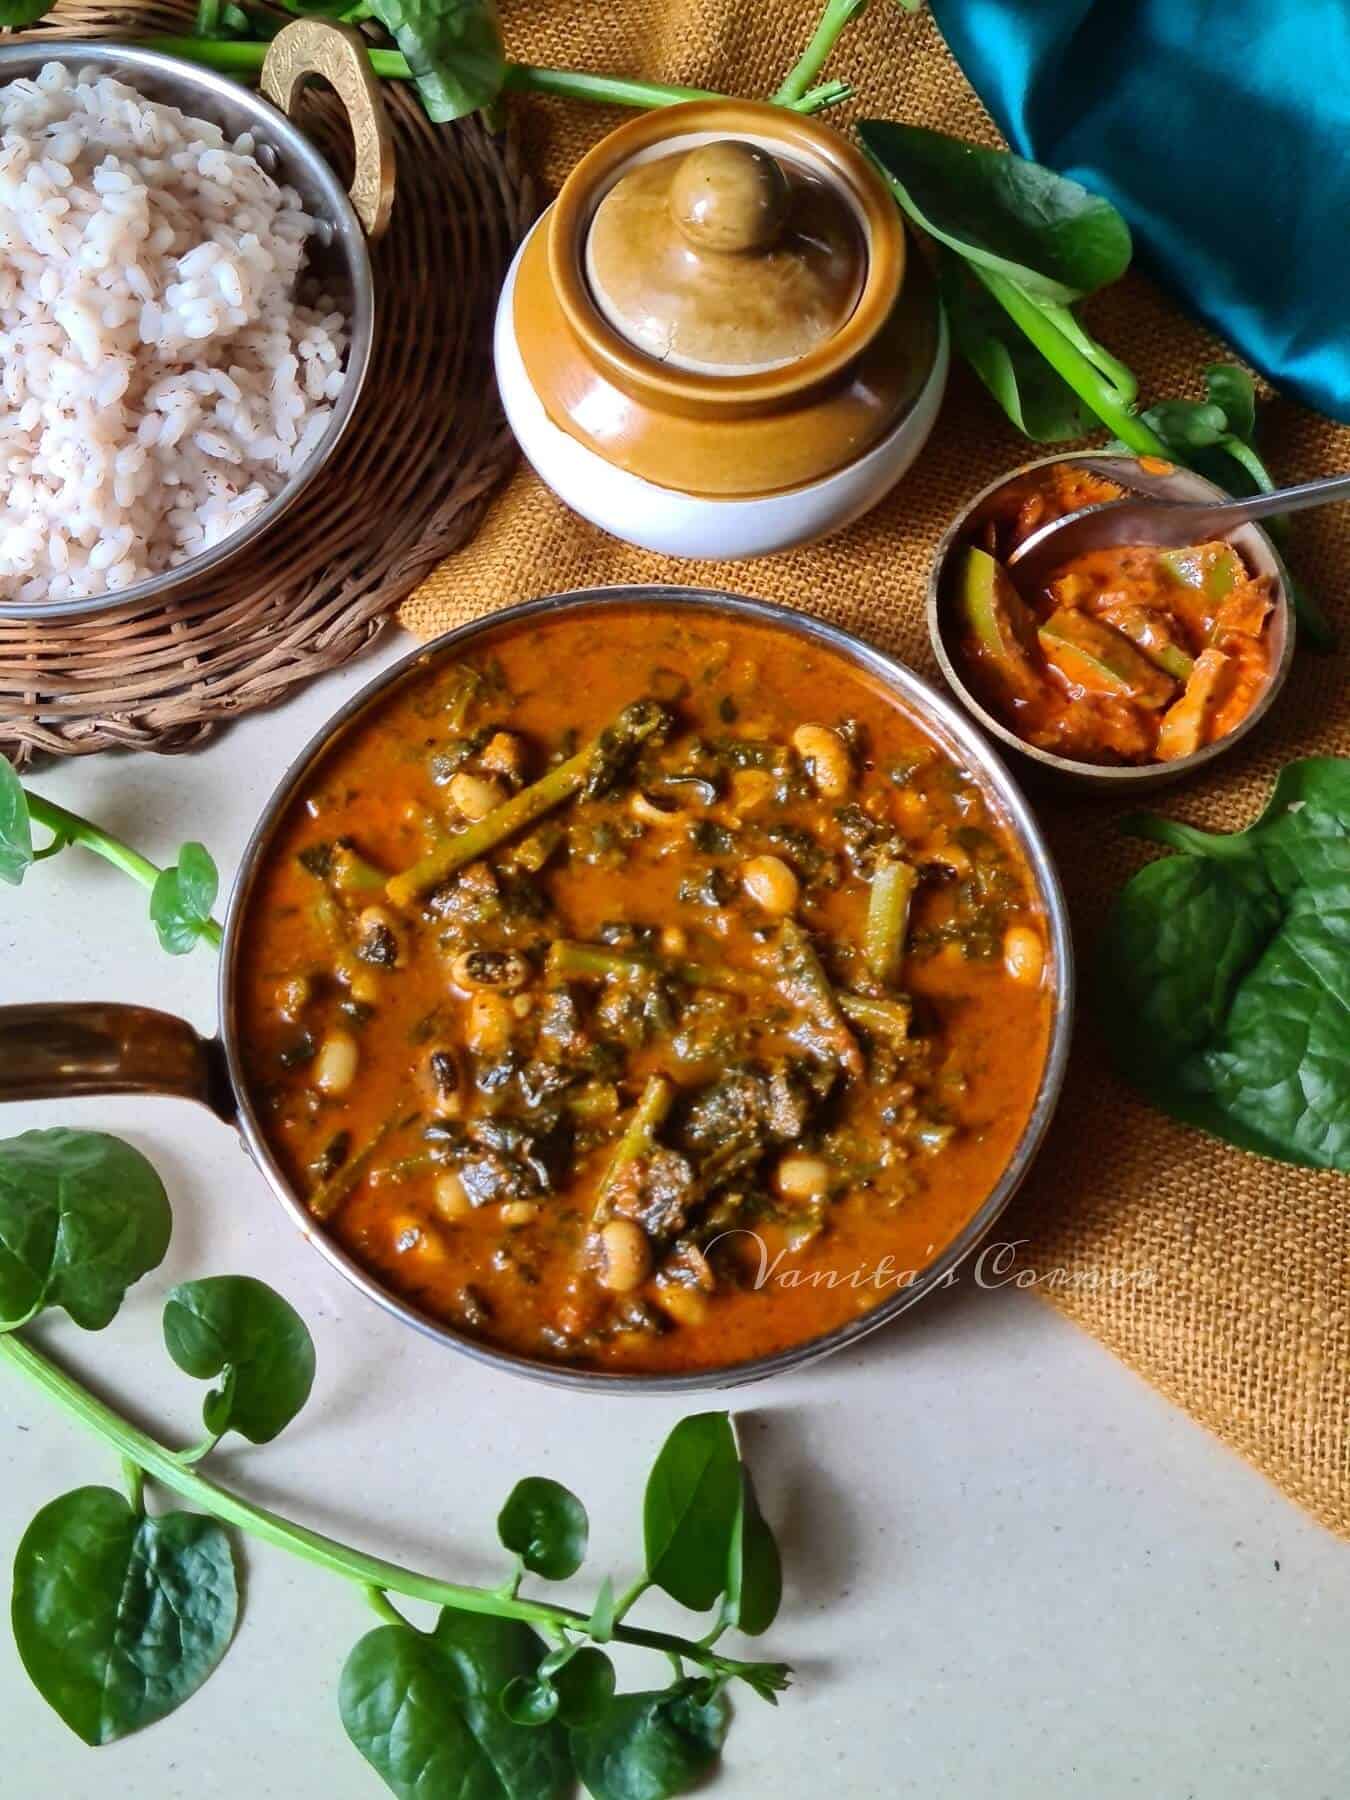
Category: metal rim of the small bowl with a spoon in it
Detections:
[{"x1": 927, "y1": 450, "x2": 1296, "y2": 790}]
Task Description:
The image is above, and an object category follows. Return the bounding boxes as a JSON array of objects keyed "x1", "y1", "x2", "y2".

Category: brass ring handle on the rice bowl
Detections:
[{"x1": 261, "y1": 18, "x2": 394, "y2": 241}]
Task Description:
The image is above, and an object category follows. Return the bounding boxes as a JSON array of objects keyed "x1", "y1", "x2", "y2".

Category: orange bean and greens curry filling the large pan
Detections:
[{"x1": 238, "y1": 605, "x2": 1057, "y2": 1373}]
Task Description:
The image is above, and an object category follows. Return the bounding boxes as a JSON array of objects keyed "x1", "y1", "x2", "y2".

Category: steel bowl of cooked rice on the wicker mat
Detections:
[{"x1": 0, "y1": 20, "x2": 389, "y2": 619}]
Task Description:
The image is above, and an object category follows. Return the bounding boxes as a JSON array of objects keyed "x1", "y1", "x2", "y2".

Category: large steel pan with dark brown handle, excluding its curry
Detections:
[{"x1": 0, "y1": 587, "x2": 1073, "y2": 1393}]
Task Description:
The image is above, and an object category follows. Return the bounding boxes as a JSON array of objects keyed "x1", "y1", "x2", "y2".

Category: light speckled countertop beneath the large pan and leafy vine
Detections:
[{"x1": 0, "y1": 637, "x2": 1350, "y2": 1800}]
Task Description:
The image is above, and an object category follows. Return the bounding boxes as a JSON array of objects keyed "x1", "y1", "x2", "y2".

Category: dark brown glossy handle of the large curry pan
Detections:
[{"x1": 0, "y1": 1001, "x2": 236, "y2": 1120}]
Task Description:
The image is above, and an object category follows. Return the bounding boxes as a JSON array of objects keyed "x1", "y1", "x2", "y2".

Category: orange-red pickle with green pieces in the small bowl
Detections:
[{"x1": 954, "y1": 463, "x2": 1273, "y2": 763}]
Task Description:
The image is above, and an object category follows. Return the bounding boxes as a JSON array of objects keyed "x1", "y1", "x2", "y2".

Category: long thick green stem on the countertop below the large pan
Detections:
[{"x1": 0, "y1": 1332, "x2": 776, "y2": 1678}]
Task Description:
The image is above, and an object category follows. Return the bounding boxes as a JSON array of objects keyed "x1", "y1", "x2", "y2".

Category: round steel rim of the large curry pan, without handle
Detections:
[{"x1": 218, "y1": 583, "x2": 1075, "y2": 1395}]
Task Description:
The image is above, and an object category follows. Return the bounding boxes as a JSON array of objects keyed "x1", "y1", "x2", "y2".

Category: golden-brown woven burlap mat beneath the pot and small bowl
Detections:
[{"x1": 403, "y1": 0, "x2": 1350, "y2": 1535}]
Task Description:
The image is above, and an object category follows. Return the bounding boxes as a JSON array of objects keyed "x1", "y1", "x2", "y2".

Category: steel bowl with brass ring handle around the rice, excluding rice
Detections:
[{"x1": 0, "y1": 18, "x2": 392, "y2": 619}]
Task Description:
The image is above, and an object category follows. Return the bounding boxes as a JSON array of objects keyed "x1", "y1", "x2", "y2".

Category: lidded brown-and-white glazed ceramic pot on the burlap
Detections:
[{"x1": 495, "y1": 101, "x2": 947, "y2": 558}]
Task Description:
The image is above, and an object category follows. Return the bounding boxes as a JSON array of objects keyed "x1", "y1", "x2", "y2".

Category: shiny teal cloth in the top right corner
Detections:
[{"x1": 931, "y1": 0, "x2": 1350, "y2": 421}]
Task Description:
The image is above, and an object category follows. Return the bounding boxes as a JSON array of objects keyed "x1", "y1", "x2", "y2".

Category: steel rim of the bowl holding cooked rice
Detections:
[{"x1": 0, "y1": 36, "x2": 374, "y2": 623}]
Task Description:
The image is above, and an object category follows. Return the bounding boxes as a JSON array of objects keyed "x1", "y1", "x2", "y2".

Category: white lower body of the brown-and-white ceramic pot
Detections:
[{"x1": 493, "y1": 214, "x2": 949, "y2": 560}]
